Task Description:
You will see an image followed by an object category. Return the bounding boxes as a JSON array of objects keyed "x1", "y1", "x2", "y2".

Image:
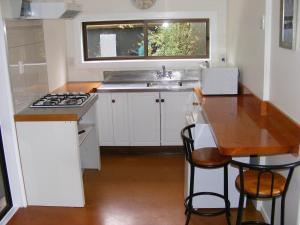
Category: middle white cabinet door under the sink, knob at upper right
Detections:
[{"x1": 128, "y1": 92, "x2": 160, "y2": 146}]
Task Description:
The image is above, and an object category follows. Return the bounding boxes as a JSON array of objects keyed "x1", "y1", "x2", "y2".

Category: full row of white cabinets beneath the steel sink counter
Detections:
[{"x1": 98, "y1": 91, "x2": 194, "y2": 146}]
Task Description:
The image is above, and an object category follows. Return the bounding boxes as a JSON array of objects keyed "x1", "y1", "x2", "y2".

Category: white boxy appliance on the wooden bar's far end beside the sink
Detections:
[{"x1": 201, "y1": 65, "x2": 239, "y2": 95}]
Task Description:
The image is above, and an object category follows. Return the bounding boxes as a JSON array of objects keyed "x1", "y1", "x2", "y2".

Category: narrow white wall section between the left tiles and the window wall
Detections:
[{"x1": 43, "y1": 20, "x2": 67, "y2": 91}]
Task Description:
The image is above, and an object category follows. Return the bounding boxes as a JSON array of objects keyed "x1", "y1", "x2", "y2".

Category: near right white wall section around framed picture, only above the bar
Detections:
[{"x1": 270, "y1": 0, "x2": 300, "y2": 123}]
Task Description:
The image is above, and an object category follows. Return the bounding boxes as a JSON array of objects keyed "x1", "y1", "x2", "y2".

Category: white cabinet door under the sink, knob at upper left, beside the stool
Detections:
[{"x1": 161, "y1": 92, "x2": 193, "y2": 145}]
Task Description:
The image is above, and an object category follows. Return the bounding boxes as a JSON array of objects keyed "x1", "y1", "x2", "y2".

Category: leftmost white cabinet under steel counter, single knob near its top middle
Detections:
[{"x1": 98, "y1": 93, "x2": 130, "y2": 146}]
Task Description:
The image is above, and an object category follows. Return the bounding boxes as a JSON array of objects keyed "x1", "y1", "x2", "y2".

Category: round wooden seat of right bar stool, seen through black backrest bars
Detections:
[{"x1": 235, "y1": 169, "x2": 286, "y2": 198}]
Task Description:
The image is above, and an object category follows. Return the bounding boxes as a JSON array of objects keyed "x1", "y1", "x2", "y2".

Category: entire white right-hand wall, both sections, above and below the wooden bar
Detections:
[{"x1": 227, "y1": 0, "x2": 300, "y2": 225}]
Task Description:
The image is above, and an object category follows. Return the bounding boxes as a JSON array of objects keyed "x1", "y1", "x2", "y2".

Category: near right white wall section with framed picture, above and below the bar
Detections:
[{"x1": 263, "y1": 0, "x2": 300, "y2": 225}]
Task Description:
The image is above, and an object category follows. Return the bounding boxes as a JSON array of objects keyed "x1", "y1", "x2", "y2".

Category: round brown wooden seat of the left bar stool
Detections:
[{"x1": 192, "y1": 147, "x2": 231, "y2": 168}]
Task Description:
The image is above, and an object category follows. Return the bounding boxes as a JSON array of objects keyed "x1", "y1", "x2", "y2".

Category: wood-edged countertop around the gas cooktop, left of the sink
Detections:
[{"x1": 14, "y1": 82, "x2": 100, "y2": 122}]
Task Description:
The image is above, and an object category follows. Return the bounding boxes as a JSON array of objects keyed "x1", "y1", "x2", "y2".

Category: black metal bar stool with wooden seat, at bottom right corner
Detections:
[{"x1": 232, "y1": 160, "x2": 300, "y2": 225}]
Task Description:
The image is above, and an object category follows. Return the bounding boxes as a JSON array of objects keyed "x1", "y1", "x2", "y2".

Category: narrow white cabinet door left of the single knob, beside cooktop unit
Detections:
[{"x1": 97, "y1": 93, "x2": 114, "y2": 146}]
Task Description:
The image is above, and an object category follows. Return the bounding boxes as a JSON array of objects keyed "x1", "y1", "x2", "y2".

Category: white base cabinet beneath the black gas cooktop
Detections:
[{"x1": 16, "y1": 100, "x2": 100, "y2": 207}]
